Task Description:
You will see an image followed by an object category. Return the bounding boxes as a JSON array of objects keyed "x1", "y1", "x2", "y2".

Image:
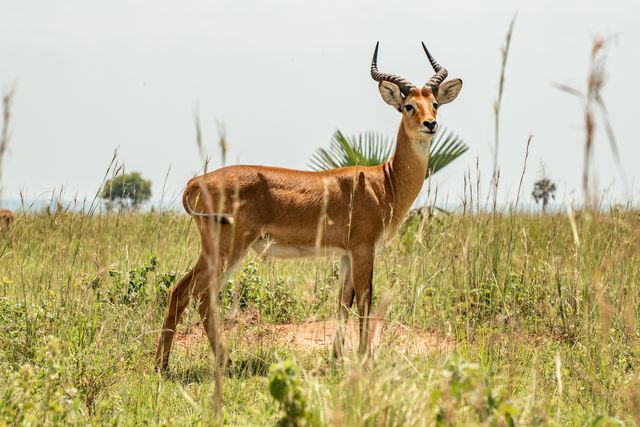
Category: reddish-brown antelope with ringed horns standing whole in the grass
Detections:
[{"x1": 156, "y1": 43, "x2": 462, "y2": 370}]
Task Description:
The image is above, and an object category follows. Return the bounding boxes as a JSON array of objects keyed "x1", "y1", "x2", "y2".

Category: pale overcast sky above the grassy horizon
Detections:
[{"x1": 0, "y1": 0, "x2": 640, "y2": 209}]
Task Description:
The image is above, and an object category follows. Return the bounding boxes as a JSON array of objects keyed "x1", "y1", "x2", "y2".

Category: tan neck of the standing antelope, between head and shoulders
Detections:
[{"x1": 383, "y1": 124, "x2": 430, "y2": 223}]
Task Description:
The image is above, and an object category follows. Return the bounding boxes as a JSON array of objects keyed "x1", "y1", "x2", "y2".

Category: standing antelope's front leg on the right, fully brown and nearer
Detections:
[{"x1": 351, "y1": 246, "x2": 374, "y2": 356}]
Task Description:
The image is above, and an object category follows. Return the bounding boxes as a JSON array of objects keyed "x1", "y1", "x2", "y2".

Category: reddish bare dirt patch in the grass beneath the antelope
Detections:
[{"x1": 175, "y1": 319, "x2": 454, "y2": 354}]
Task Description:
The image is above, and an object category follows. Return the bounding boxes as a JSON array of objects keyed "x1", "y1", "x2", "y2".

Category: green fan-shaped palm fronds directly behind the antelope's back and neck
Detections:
[{"x1": 310, "y1": 129, "x2": 469, "y2": 179}]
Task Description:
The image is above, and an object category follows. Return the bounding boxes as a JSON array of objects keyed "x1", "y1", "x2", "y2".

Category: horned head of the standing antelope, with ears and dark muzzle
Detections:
[{"x1": 371, "y1": 43, "x2": 462, "y2": 142}]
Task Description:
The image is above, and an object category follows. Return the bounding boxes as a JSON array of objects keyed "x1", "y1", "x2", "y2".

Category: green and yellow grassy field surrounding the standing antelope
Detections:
[{"x1": 0, "y1": 206, "x2": 640, "y2": 425}]
